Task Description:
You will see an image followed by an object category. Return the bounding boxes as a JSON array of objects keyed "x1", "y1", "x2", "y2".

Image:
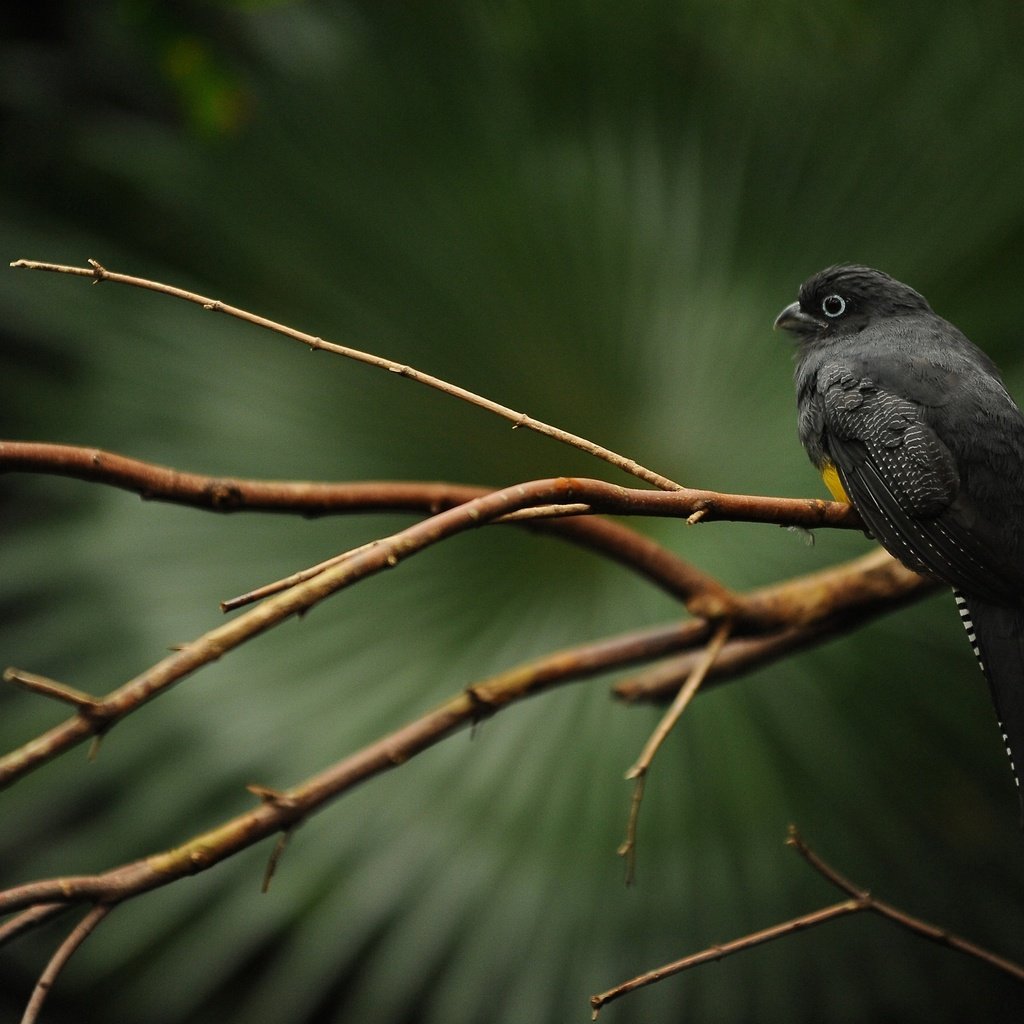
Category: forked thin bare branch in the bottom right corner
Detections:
[{"x1": 590, "y1": 825, "x2": 1024, "y2": 1020}]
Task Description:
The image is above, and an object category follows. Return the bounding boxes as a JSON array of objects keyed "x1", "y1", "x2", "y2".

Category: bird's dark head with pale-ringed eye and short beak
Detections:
[{"x1": 775, "y1": 265, "x2": 931, "y2": 342}]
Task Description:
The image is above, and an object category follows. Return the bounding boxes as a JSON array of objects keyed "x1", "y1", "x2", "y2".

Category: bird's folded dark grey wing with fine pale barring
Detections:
[{"x1": 817, "y1": 364, "x2": 1019, "y2": 603}]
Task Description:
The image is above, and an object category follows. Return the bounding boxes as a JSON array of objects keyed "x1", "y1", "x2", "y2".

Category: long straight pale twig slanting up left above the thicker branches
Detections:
[{"x1": 10, "y1": 259, "x2": 680, "y2": 490}]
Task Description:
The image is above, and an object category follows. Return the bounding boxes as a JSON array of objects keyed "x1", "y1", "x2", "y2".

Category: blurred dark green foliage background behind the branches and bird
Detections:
[{"x1": 0, "y1": 0, "x2": 1024, "y2": 1024}]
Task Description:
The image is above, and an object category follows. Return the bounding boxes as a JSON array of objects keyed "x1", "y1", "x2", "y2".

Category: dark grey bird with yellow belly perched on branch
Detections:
[{"x1": 775, "y1": 264, "x2": 1024, "y2": 815}]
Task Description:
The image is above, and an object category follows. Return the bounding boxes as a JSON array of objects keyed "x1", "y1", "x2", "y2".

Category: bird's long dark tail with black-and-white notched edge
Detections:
[{"x1": 953, "y1": 591, "x2": 1024, "y2": 811}]
